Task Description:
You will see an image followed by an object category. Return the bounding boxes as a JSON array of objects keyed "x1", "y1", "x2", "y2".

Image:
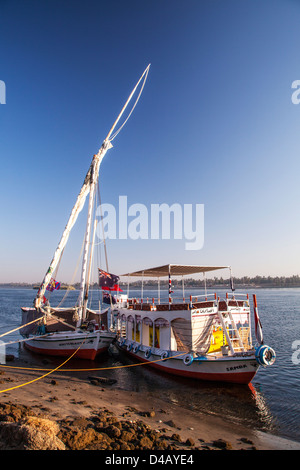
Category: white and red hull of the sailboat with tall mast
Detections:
[{"x1": 25, "y1": 330, "x2": 115, "y2": 360}]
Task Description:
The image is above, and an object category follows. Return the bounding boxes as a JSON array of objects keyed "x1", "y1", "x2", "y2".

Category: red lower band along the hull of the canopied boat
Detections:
[{"x1": 124, "y1": 351, "x2": 257, "y2": 385}]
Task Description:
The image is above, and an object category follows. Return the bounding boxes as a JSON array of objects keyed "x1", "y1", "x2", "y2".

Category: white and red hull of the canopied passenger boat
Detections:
[{"x1": 117, "y1": 341, "x2": 259, "y2": 384}]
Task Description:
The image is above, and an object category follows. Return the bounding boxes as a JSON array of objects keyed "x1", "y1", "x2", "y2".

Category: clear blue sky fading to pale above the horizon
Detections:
[{"x1": 0, "y1": 0, "x2": 300, "y2": 282}]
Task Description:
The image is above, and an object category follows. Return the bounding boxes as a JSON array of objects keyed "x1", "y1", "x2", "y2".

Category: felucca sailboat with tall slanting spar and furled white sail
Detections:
[{"x1": 20, "y1": 65, "x2": 150, "y2": 360}]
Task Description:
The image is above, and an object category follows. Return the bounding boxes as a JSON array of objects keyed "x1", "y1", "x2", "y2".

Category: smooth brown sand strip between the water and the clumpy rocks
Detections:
[{"x1": 0, "y1": 359, "x2": 300, "y2": 451}]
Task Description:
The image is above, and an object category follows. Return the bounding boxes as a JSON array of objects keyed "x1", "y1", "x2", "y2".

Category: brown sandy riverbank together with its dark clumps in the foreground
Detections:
[{"x1": 0, "y1": 359, "x2": 300, "y2": 451}]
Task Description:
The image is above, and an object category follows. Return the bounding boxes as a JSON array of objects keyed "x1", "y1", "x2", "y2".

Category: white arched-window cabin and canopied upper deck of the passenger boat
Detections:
[{"x1": 113, "y1": 265, "x2": 252, "y2": 356}]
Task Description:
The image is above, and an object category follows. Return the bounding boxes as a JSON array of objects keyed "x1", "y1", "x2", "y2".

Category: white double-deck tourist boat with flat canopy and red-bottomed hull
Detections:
[{"x1": 114, "y1": 264, "x2": 276, "y2": 384}]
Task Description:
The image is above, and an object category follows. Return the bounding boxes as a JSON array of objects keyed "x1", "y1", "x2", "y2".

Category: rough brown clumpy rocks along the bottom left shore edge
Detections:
[{"x1": 0, "y1": 402, "x2": 234, "y2": 450}]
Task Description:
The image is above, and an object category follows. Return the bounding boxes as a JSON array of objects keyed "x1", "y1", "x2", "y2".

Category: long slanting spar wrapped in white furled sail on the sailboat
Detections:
[{"x1": 34, "y1": 64, "x2": 150, "y2": 309}]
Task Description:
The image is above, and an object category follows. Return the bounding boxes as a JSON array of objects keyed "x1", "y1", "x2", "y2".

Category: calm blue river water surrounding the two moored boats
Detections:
[{"x1": 0, "y1": 288, "x2": 300, "y2": 442}]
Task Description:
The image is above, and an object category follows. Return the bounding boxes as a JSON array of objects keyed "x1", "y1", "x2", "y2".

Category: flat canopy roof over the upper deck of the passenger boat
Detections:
[{"x1": 122, "y1": 264, "x2": 229, "y2": 277}]
